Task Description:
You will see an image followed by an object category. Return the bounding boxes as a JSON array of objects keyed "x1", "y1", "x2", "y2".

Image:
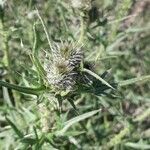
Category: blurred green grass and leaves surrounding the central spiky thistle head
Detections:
[{"x1": 0, "y1": 0, "x2": 150, "y2": 150}]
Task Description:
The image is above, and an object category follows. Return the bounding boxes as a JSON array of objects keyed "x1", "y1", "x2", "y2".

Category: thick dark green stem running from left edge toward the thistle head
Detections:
[{"x1": 0, "y1": 80, "x2": 45, "y2": 95}]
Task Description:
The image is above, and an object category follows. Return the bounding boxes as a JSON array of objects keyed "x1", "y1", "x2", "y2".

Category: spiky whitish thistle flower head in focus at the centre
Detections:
[{"x1": 45, "y1": 42, "x2": 83, "y2": 90}]
